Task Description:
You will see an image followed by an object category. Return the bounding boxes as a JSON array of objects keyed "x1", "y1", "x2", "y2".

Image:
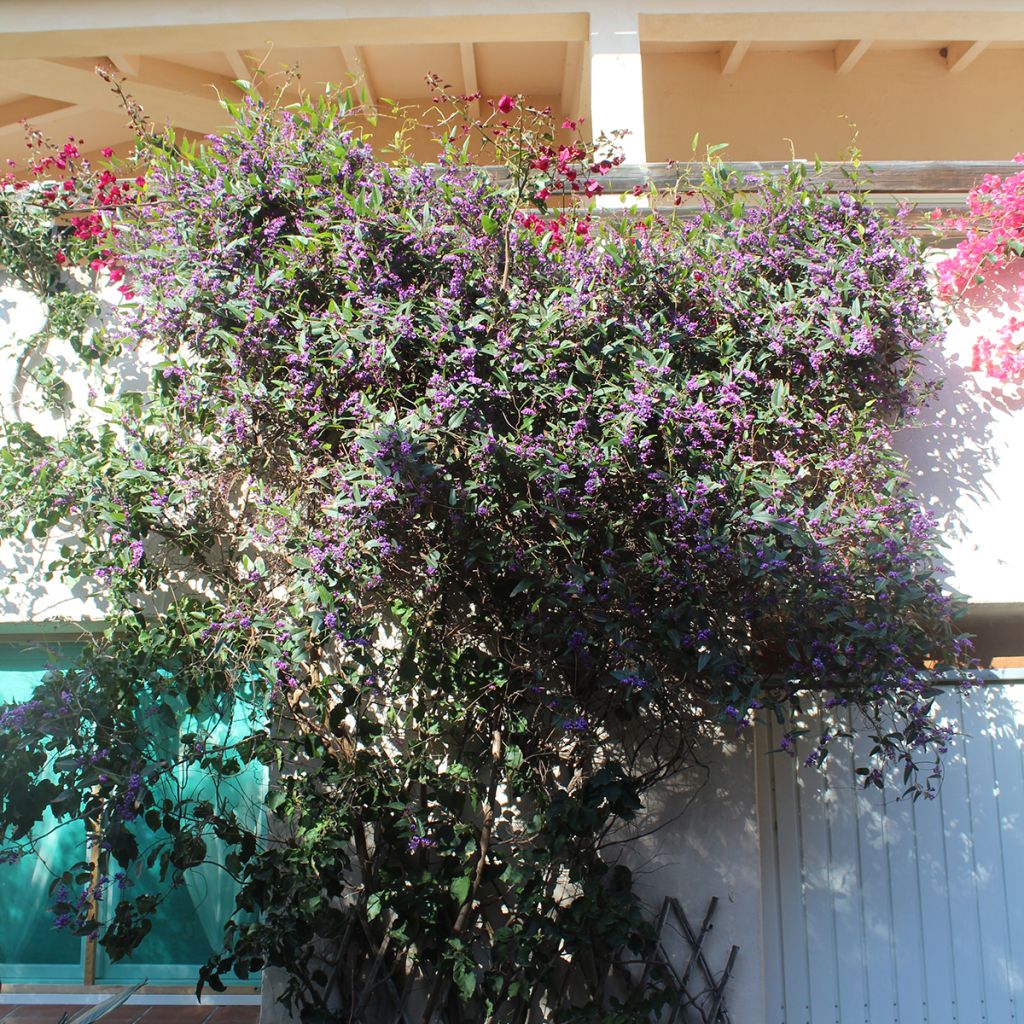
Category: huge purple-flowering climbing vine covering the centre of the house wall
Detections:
[{"x1": 0, "y1": 88, "x2": 962, "y2": 1021}]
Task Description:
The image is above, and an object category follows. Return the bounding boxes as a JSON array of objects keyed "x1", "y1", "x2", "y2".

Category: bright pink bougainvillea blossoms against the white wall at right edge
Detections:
[{"x1": 936, "y1": 155, "x2": 1024, "y2": 383}]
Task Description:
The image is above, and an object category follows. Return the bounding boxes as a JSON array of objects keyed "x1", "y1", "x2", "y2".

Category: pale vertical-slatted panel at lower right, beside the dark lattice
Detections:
[{"x1": 759, "y1": 683, "x2": 1024, "y2": 1024}]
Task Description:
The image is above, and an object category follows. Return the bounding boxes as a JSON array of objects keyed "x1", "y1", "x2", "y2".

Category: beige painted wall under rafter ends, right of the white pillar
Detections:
[{"x1": 643, "y1": 43, "x2": 1024, "y2": 161}]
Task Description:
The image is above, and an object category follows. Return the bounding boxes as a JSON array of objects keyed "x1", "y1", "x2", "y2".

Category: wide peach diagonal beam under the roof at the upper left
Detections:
[{"x1": 0, "y1": 60, "x2": 229, "y2": 133}]
